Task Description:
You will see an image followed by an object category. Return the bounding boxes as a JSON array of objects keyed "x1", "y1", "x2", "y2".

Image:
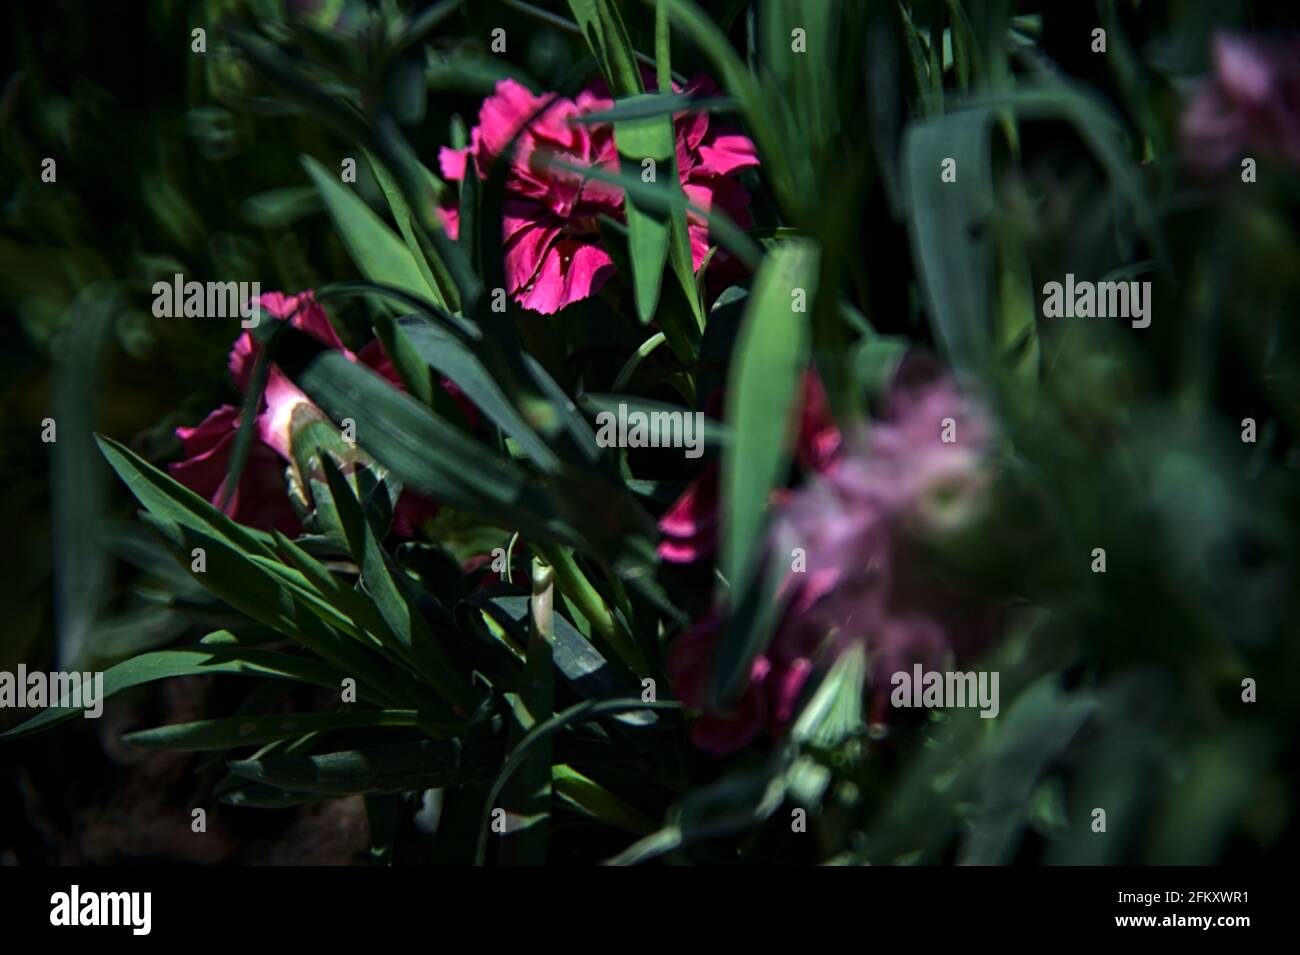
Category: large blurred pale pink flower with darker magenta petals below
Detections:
[{"x1": 670, "y1": 360, "x2": 996, "y2": 752}]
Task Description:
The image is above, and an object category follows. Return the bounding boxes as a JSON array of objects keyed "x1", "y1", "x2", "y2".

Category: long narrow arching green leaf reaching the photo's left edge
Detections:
[{"x1": 0, "y1": 644, "x2": 347, "y2": 739}]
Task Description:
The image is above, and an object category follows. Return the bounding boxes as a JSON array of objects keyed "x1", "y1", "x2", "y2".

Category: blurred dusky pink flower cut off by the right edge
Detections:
[{"x1": 1182, "y1": 34, "x2": 1300, "y2": 174}]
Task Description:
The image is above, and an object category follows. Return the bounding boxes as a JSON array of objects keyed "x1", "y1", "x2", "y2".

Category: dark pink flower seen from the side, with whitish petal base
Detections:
[{"x1": 168, "y1": 290, "x2": 467, "y2": 537}]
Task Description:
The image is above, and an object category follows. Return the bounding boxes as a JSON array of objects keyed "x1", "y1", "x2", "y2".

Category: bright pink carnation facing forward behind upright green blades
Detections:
[{"x1": 438, "y1": 77, "x2": 758, "y2": 314}]
